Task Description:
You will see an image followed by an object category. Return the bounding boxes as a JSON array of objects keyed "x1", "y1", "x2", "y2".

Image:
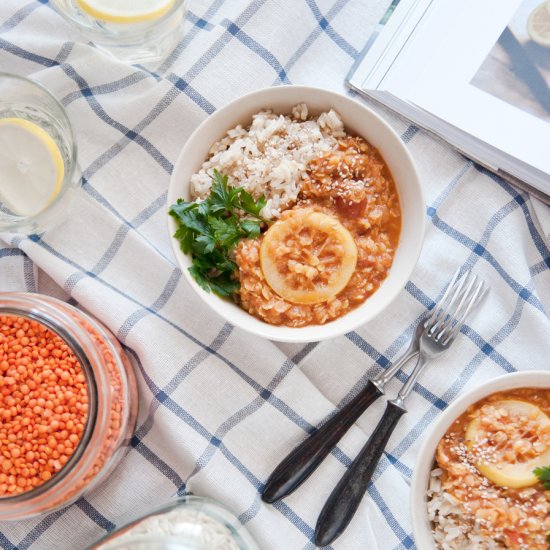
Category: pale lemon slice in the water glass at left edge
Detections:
[{"x1": 0, "y1": 118, "x2": 65, "y2": 216}]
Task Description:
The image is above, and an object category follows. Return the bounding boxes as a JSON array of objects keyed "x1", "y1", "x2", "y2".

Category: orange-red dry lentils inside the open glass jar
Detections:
[{"x1": 0, "y1": 316, "x2": 88, "y2": 497}]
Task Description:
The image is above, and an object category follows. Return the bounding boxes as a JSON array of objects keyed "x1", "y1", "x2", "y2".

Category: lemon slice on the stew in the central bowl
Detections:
[{"x1": 260, "y1": 209, "x2": 357, "y2": 304}]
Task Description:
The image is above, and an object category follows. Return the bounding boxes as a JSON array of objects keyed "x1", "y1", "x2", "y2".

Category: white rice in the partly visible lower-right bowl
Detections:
[{"x1": 428, "y1": 468, "x2": 506, "y2": 550}]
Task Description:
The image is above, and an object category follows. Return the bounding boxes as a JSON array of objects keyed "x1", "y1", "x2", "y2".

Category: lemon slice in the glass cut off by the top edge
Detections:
[{"x1": 76, "y1": 0, "x2": 176, "y2": 24}]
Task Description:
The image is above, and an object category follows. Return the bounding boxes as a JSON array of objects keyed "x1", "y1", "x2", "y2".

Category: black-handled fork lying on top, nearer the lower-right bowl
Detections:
[{"x1": 315, "y1": 270, "x2": 487, "y2": 546}]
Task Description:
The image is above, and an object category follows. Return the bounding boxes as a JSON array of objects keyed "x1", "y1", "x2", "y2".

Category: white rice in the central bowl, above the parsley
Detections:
[{"x1": 191, "y1": 103, "x2": 346, "y2": 219}]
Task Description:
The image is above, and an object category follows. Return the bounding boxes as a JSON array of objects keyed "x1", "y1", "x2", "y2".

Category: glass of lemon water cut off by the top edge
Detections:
[{"x1": 50, "y1": 0, "x2": 187, "y2": 64}]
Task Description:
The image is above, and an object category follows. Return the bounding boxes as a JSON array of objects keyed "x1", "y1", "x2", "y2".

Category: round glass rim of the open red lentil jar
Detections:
[{"x1": 0, "y1": 300, "x2": 99, "y2": 504}]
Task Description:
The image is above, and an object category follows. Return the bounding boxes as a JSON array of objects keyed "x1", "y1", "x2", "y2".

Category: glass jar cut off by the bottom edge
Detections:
[{"x1": 89, "y1": 495, "x2": 258, "y2": 550}]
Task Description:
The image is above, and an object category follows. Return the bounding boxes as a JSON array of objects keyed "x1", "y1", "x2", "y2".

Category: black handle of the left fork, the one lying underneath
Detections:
[{"x1": 262, "y1": 380, "x2": 384, "y2": 504}]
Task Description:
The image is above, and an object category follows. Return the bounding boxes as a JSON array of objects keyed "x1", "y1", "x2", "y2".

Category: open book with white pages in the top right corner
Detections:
[{"x1": 347, "y1": 0, "x2": 550, "y2": 204}]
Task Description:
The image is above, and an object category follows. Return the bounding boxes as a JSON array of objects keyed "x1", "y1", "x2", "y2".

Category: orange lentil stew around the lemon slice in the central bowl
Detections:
[{"x1": 236, "y1": 137, "x2": 401, "y2": 327}]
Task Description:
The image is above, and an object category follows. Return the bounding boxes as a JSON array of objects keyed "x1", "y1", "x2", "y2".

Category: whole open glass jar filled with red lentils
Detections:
[{"x1": 0, "y1": 293, "x2": 137, "y2": 521}]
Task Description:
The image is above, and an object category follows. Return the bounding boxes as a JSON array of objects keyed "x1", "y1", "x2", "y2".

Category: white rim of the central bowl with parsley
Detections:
[{"x1": 167, "y1": 85, "x2": 426, "y2": 343}]
